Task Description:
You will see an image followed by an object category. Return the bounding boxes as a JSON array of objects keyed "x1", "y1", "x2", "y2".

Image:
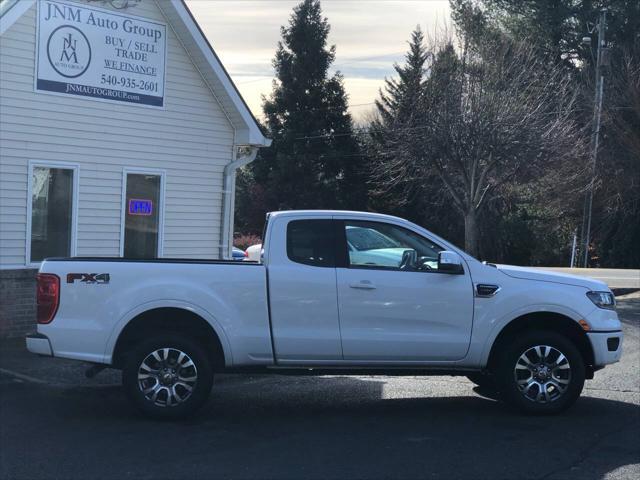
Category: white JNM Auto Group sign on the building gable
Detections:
[{"x1": 35, "y1": 0, "x2": 167, "y2": 107}]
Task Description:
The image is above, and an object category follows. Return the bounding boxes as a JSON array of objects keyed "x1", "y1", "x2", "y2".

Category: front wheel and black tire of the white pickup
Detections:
[{"x1": 495, "y1": 331, "x2": 585, "y2": 415}]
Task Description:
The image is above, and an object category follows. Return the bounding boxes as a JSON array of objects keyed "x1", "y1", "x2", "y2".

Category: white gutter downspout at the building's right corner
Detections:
[{"x1": 220, "y1": 145, "x2": 258, "y2": 259}]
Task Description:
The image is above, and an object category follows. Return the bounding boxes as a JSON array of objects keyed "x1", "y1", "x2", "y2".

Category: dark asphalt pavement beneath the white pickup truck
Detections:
[{"x1": 0, "y1": 294, "x2": 640, "y2": 480}]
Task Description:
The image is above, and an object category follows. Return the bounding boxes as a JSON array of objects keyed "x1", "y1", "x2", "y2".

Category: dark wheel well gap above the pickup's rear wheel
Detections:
[{"x1": 111, "y1": 306, "x2": 231, "y2": 370}]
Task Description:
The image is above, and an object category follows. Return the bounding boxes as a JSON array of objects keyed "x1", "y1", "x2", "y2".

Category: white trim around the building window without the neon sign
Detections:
[{"x1": 24, "y1": 160, "x2": 80, "y2": 268}]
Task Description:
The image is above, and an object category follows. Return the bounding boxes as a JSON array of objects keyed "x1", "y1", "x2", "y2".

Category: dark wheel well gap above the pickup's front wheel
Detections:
[{"x1": 486, "y1": 311, "x2": 594, "y2": 378}]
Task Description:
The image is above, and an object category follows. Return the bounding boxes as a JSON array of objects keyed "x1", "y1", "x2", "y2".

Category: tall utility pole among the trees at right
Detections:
[{"x1": 582, "y1": 9, "x2": 607, "y2": 268}]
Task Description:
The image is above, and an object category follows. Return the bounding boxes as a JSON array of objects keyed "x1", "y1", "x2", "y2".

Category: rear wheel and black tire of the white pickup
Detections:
[{"x1": 122, "y1": 332, "x2": 213, "y2": 419}]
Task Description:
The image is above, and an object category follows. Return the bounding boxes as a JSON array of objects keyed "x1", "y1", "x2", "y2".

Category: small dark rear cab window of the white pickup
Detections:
[{"x1": 287, "y1": 220, "x2": 335, "y2": 267}]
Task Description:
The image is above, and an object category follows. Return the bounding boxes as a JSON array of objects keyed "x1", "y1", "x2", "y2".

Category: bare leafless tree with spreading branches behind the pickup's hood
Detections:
[{"x1": 374, "y1": 40, "x2": 585, "y2": 255}]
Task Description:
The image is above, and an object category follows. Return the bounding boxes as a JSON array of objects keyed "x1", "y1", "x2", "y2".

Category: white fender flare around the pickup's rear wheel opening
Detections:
[{"x1": 104, "y1": 300, "x2": 233, "y2": 367}]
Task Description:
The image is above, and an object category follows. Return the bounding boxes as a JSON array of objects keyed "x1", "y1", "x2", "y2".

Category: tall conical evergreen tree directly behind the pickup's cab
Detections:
[{"x1": 245, "y1": 0, "x2": 366, "y2": 230}]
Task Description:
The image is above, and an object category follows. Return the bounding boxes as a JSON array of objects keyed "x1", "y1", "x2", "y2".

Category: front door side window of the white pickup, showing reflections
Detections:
[{"x1": 345, "y1": 221, "x2": 443, "y2": 271}]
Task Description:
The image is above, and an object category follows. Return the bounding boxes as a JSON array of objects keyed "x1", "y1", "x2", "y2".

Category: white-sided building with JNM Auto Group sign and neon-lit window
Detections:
[{"x1": 0, "y1": 0, "x2": 270, "y2": 335}]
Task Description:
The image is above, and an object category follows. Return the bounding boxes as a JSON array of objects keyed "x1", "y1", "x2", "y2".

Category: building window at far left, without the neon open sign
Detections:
[{"x1": 29, "y1": 166, "x2": 76, "y2": 262}]
